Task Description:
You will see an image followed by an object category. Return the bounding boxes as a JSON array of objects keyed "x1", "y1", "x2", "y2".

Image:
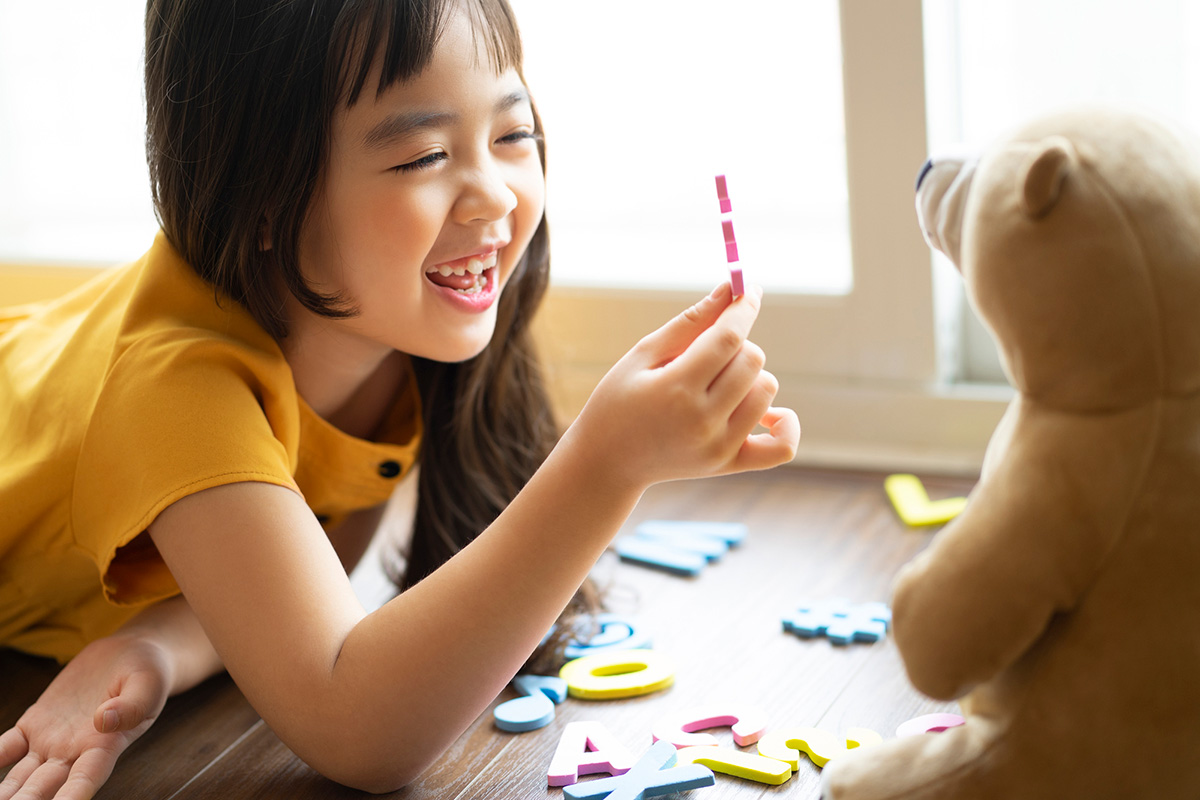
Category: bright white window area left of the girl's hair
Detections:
[{"x1": 0, "y1": 0, "x2": 157, "y2": 267}]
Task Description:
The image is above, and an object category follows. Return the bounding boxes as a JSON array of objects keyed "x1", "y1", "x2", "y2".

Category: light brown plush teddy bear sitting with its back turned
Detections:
[{"x1": 822, "y1": 108, "x2": 1200, "y2": 800}]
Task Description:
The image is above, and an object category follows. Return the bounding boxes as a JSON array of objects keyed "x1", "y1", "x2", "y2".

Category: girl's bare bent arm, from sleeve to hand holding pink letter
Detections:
[{"x1": 150, "y1": 285, "x2": 799, "y2": 792}]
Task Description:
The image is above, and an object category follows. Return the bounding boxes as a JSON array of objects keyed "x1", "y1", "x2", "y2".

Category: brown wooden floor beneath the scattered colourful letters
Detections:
[{"x1": 0, "y1": 469, "x2": 972, "y2": 800}]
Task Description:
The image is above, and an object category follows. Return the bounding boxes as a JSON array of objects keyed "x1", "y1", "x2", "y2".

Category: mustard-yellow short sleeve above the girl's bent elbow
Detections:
[{"x1": 71, "y1": 331, "x2": 299, "y2": 604}]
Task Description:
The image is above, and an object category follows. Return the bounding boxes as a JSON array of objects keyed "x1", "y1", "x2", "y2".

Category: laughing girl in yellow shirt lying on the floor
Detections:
[{"x1": 0, "y1": 0, "x2": 799, "y2": 800}]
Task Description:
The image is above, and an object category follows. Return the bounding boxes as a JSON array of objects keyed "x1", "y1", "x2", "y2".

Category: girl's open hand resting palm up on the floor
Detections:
[{"x1": 0, "y1": 634, "x2": 172, "y2": 800}]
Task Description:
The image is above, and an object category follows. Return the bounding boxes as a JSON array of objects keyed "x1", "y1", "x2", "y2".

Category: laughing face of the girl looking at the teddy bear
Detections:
[{"x1": 300, "y1": 5, "x2": 545, "y2": 362}]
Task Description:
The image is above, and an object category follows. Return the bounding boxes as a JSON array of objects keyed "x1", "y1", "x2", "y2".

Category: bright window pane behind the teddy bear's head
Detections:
[{"x1": 924, "y1": 0, "x2": 1200, "y2": 383}]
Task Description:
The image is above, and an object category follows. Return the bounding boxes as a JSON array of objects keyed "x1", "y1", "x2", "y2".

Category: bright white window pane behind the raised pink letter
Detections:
[{"x1": 511, "y1": 0, "x2": 851, "y2": 294}]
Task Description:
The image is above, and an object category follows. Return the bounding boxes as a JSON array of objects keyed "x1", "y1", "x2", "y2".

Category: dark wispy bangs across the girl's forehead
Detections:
[{"x1": 338, "y1": 0, "x2": 522, "y2": 106}]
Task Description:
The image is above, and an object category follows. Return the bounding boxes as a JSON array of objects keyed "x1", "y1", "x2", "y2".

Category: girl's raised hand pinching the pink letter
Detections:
[{"x1": 572, "y1": 283, "x2": 800, "y2": 487}]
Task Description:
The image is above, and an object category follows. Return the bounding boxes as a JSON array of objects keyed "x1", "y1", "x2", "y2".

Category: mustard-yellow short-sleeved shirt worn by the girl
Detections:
[{"x1": 0, "y1": 233, "x2": 420, "y2": 661}]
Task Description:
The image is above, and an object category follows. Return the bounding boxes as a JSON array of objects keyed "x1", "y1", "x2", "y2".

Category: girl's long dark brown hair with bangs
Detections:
[{"x1": 145, "y1": 0, "x2": 600, "y2": 666}]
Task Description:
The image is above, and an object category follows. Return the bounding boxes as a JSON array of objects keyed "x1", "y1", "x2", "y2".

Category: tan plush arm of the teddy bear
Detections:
[{"x1": 893, "y1": 398, "x2": 1157, "y2": 699}]
